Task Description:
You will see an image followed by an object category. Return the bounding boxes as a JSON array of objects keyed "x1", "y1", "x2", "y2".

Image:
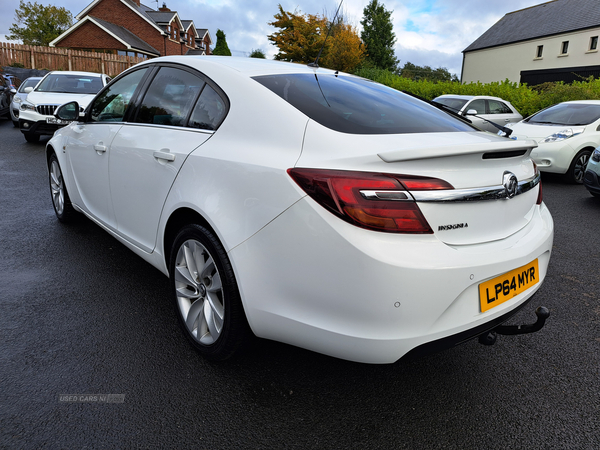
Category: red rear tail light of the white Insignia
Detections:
[{"x1": 288, "y1": 169, "x2": 454, "y2": 234}]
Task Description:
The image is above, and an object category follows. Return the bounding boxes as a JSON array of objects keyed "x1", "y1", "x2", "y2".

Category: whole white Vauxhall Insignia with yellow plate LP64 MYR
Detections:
[{"x1": 46, "y1": 56, "x2": 553, "y2": 363}]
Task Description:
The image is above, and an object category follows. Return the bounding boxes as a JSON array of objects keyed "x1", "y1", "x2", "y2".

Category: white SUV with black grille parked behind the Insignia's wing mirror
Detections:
[{"x1": 19, "y1": 71, "x2": 110, "y2": 142}]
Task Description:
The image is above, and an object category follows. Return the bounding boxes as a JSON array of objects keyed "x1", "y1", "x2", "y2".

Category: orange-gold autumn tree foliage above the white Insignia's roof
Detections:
[{"x1": 268, "y1": 5, "x2": 364, "y2": 72}]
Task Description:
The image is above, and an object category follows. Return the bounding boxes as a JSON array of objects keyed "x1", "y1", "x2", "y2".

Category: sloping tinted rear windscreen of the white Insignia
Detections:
[{"x1": 254, "y1": 74, "x2": 475, "y2": 134}]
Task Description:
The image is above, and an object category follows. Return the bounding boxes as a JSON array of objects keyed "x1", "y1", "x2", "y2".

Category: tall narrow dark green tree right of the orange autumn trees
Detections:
[{"x1": 360, "y1": 0, "x2": 398, "y2": 71}]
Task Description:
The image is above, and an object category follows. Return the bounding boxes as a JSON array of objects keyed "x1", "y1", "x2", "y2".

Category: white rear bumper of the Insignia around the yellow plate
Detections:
[{"x1": 230, "y1": 199, "x2": 553, "y2": 363}]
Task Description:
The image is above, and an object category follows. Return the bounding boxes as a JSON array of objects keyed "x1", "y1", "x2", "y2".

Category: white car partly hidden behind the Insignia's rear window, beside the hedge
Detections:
[{"x1": 433, "y1": 94, "x2": 523, "y2": 134}]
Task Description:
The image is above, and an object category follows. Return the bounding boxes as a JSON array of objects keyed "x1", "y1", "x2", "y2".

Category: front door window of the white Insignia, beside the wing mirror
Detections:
[{"x1": 90, "y1": 68, "x2": 148, "y2": 122}]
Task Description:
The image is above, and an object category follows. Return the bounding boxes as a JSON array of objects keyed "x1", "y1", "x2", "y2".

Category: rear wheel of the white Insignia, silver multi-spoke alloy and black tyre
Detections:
[{"x1": 169, "y1": 225, "x2": 251, "y2": 361}]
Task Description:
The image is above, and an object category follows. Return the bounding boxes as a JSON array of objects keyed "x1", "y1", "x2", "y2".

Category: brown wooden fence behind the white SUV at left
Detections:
[{"x1": 0, "y1": 42, "x2": 144, "y2": 77}]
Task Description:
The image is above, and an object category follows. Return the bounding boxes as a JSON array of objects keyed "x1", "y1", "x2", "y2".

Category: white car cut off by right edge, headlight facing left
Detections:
[{"x1": 499, "y1": 100, "x2": 600, "y2": 184}]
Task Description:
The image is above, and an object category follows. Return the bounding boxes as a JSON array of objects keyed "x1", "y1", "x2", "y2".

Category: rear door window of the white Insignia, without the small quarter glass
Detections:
[{"x1": 135, "y1": 67, "x2": 205, "y2": 126}]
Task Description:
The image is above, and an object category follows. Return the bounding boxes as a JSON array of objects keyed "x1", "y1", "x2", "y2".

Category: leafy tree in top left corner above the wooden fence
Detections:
[{"x1": 6, "y1": 0, "x2": 73, "y2": 45}]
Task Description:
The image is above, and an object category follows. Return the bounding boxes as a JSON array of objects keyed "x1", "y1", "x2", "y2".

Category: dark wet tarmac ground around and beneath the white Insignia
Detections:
[{"x1": 0, "y1": 119, "x2": 600, "y2": 450}]
